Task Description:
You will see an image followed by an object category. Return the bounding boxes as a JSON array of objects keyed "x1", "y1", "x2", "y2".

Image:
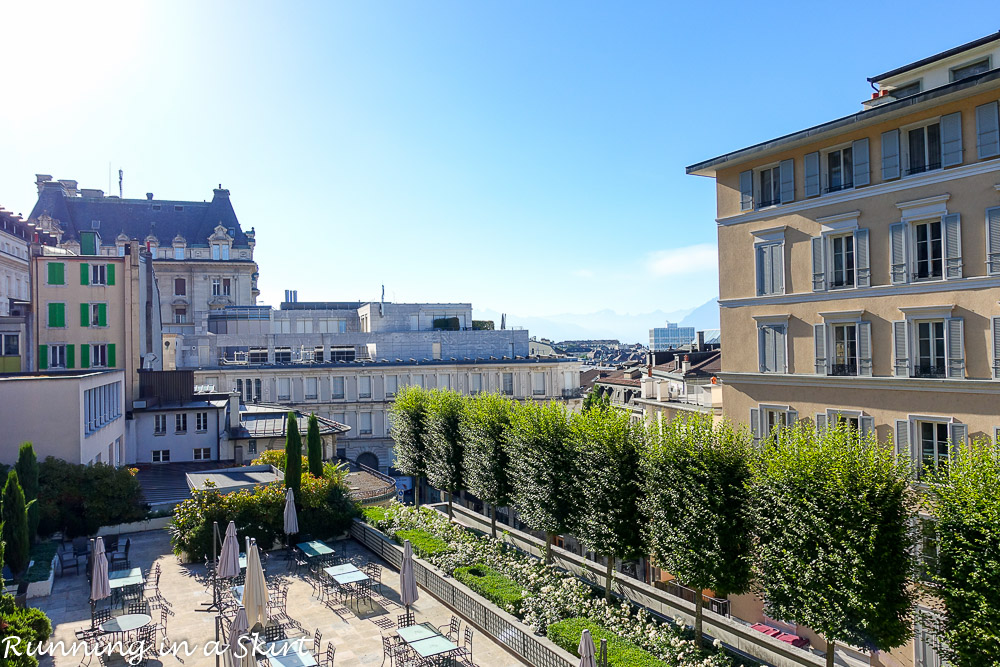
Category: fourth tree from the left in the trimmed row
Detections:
[{"x1": 509, "y1": 403, "x2": 583, "y2": 563}]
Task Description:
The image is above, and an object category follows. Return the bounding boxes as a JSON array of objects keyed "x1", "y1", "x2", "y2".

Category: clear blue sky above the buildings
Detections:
[{"x1": 0, "y1": 0, "x2": 1000, "y2": 318}]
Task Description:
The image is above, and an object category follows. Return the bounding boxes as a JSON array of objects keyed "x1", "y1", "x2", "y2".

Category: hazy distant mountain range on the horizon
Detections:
[{"x1": 473, "y1": 299, "x2": 719, "y2": 345}]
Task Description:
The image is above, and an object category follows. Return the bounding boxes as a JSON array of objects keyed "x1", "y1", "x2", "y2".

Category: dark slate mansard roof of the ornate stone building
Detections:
[{"x1": 28, "y1": 181, "x2": 248, "y2": 247}]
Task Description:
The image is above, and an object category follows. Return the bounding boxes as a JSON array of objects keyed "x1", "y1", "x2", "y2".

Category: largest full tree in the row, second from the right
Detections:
[{"x1": 752, "y1": 421, "x2": 914, "y2": 666}]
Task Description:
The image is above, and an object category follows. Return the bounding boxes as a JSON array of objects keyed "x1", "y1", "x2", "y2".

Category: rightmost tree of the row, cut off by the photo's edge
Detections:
[{"x1": 928, "y1": 441, "x2": 1000, "y2": 666}]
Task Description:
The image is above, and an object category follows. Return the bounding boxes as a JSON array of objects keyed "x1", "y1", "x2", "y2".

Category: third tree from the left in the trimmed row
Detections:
[{"x1": 462, "y1": 394, "x2": 517, "y2": 538}]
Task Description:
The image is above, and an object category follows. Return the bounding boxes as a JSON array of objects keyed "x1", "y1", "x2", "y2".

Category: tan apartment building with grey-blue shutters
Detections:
[{"x1": 687, "y1": 33, "x2": 1000, "y2": 665}]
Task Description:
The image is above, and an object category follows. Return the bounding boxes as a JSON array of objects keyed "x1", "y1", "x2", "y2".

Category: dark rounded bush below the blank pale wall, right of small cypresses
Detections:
[{"x1": 38, "y1": 456, "x2": 149, "y2": 538}]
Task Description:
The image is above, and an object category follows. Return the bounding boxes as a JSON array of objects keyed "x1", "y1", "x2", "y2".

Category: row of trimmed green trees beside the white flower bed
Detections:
[{"x1": 392, "y1": 387, "x2": 984, "y2": 664}]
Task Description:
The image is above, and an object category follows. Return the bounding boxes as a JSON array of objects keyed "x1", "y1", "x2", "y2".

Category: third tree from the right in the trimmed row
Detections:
[{"x1": 643, "y1": 416, "x2": 752, "y2": 645}]
